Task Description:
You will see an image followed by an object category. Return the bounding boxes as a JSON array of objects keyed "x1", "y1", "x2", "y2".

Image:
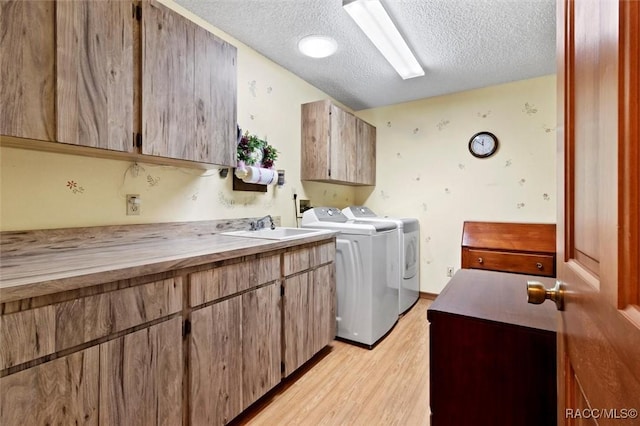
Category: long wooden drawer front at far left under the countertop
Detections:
[{"x1": 0, "y1": 277, "x2": 182, "y2": 370}]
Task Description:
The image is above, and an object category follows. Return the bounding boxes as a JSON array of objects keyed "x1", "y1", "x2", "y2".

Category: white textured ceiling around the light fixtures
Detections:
[{"x1": 176, "y1": 0, "x2": 555, "y2": 110}]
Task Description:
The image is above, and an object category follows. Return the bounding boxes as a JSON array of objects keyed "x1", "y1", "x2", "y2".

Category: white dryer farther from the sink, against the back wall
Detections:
[{"x1": 342, "y1": 206, "x2": 420, "y2": 314}]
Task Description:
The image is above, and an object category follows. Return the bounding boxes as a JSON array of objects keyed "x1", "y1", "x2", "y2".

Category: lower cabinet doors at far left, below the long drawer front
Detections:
[{"x1": 0, "y1": 317, "x2": 183, "y2": 426}]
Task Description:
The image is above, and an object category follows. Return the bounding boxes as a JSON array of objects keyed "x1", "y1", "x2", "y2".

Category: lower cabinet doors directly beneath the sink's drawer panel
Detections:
[{"x1": 189, "y1": 282, "x2": 282, "y2": 425}]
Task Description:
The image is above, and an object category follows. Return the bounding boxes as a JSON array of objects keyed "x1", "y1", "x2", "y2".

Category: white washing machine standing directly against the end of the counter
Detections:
[{"x1": 301, "y1": 207, "x2": 399, "y2": 349}]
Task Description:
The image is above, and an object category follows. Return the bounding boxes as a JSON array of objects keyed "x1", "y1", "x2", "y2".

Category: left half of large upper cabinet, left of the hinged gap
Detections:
[{"x1": 0, "y1": 1, "x2": 134, "y2": 152}]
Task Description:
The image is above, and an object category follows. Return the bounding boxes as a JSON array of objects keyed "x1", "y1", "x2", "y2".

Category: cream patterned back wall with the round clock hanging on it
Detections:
[{"x1": 356, "y1": 76, "x2": 556, "y2": 293}]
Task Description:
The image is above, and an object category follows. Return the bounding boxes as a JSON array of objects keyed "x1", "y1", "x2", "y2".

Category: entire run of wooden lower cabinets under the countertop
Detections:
[{"x1": 0, "y1": 240, "x2": 336, "y2": 426}]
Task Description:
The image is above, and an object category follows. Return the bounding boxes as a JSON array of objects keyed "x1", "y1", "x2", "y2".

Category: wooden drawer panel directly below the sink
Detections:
[{"x1": 189, "y1": 255, "x2": 280, "y2": 306}]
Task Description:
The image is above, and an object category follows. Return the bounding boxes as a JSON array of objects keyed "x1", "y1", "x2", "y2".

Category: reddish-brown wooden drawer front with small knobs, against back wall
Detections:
[{"x1": 463, "y1": 249, "x2": 555, "y2": 277}]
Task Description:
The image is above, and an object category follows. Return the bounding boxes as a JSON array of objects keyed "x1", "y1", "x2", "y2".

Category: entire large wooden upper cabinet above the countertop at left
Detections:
[{"x1": 0, "y1": 0, "x2": 237, "y2": 166}]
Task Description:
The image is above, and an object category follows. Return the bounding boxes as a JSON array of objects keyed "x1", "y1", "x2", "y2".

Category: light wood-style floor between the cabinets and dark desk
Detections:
[{"x1": 234, "y1": 299, "x2": 431, "y2": 426}]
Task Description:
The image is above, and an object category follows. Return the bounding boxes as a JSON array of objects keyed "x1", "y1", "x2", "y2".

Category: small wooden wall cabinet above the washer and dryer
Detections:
[{"x1": 301, "y1": 100, "x2": 376, "y2": 185}]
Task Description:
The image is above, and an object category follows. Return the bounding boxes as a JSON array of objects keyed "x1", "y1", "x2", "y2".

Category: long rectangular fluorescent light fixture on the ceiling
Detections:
[{"x1": 342, "y1": 0, "x2": 424, "y2": 80}]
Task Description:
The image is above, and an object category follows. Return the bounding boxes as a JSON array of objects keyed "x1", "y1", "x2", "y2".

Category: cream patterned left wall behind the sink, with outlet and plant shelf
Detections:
[{"x1": 0, "y1": 1, "x2": 355, "y2": 231}]
